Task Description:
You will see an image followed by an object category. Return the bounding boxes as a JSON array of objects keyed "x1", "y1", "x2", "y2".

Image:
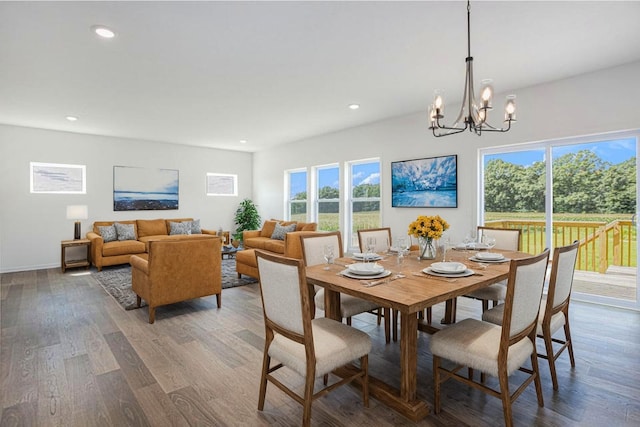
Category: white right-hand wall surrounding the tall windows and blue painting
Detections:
[{"x1": 253, "y1": 62, "x2": 640, "y2": 247}]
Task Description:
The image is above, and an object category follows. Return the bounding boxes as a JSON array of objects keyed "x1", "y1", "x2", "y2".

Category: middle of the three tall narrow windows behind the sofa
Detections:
[{"x1": 314, "y1": 165, "x2": 340, "y2": 231}]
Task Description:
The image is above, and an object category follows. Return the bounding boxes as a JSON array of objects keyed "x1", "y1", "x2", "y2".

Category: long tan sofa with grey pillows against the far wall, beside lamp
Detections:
[{"x1": 87, "y1": 218, "x2": 217, "y2": 271}]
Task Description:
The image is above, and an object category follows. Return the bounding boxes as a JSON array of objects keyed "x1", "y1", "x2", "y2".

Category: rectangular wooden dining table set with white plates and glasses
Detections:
[{"x1": 306, "y1": 250, "x2": 530, "y2": 421}]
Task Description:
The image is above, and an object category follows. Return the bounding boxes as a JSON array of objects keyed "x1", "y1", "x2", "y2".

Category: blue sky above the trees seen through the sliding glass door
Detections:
[{"x1": 485, "y1": 138, "x2": 636, "y2": 166}]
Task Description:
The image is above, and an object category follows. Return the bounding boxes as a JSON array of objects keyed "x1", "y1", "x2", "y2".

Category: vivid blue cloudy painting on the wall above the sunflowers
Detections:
[{"x1": 391, "y1": 155, "x2": 458, "y2": 208}]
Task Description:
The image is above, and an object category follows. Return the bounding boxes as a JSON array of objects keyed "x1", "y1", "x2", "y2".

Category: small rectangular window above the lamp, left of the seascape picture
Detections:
[{"x1": 30, "y1": 162, "x2": 87, "y2": 194}]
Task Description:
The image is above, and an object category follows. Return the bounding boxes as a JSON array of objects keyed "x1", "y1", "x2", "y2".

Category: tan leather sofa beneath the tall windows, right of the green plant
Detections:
[{"x1": 236, "y1": 220, "x2": 317, "y2": 279}]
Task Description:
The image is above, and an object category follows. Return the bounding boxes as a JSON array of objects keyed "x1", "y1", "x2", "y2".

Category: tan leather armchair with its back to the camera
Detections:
[{"x1": 130, "y1": 235, "x2": 222, "y2": 323}]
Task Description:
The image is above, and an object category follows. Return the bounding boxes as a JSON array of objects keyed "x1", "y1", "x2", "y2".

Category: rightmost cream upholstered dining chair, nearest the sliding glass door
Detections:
[{"x1": 482, "y1": 240, "x2": 579, "y2": 390}]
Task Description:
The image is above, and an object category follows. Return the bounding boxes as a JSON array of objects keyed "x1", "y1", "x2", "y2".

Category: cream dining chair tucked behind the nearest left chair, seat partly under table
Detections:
[{"x1": 300, "y1": 231, "x2": 391, "y2": 342}]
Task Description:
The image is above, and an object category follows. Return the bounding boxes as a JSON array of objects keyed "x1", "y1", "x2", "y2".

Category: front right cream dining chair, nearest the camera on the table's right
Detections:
[{"x1": 430, "y1": 249, "x2": 549, "y2": 426}]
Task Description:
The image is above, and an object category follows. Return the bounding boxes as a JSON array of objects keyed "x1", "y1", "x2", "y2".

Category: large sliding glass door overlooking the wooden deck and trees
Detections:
[{"x1": 479, "y1": 132, "x2": 640, "y2": 308}]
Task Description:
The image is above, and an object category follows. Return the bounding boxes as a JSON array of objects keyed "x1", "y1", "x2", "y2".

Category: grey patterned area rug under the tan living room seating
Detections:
[{"x1": 92, "y1": 258, "x2": 257, "y2": 310}]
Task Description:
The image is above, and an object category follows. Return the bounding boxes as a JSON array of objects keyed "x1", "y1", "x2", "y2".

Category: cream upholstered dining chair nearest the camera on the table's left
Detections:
[{"x1": 255, "y1": 250, "x2": 371, "y2": 426}]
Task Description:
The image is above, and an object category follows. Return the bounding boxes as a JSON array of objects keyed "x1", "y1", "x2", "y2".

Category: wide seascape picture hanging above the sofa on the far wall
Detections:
[{"x1": 113, "y1": 166, "x2": 179, "y2": 211}]
